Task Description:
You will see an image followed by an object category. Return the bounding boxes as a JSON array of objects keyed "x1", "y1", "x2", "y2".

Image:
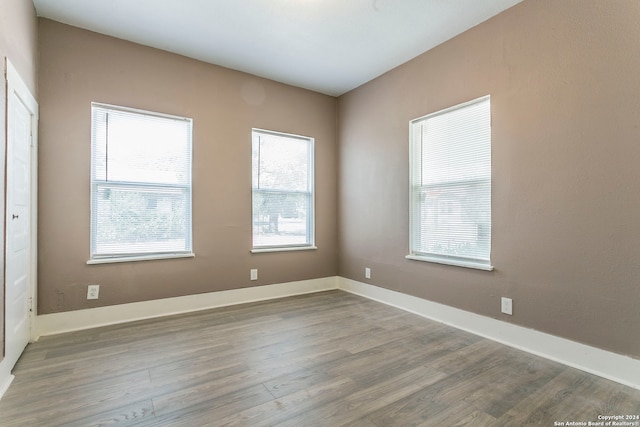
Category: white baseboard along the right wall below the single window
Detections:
[{"x1": 338, "y1": 277, "x2": 640, "y2": 389}]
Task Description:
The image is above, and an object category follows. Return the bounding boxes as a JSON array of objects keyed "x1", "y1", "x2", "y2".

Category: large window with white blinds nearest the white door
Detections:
[{"x1": 89, "y1": 103, "x2": 193, "y2": 263}]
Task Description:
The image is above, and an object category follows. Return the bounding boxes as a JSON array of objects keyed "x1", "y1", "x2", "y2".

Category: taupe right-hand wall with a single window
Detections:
[{"x1": 338, "y1": 0, "x2": 640, "y2": 357}]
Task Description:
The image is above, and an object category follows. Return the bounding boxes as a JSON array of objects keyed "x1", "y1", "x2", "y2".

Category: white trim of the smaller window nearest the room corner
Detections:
[{"x1": 250, "y1": 128, "x2": 318, "y2": 254}]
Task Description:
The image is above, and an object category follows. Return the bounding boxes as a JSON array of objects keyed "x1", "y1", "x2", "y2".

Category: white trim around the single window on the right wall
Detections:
[{"x1": 405, "y1": 95, "x2": 494, "y2": 271}]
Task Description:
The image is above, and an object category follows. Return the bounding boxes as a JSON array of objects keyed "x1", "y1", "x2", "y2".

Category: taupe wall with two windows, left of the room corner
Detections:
[{"x1": 38, "y1": 19, "x2": 338, "y2": 314}]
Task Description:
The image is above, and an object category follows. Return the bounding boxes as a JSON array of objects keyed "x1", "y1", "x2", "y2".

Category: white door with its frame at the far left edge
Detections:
[{"x1": 5, "y1": 61, "x2": 37, "y2": 372}]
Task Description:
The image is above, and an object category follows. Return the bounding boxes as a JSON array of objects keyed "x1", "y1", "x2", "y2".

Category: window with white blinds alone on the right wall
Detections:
[{"x1": 407, "y1": 96, "x2": 493, "y2": 270}]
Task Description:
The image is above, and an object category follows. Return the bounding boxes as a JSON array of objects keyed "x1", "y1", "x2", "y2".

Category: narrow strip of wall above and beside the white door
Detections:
[{"x1": 0, "y1": 0, "x2": 38, "y2": 360}]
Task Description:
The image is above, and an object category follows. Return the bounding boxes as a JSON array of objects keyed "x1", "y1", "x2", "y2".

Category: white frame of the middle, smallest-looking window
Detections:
[{"x1": 251, "y1": 128, "x2": 317, "y2": 253}]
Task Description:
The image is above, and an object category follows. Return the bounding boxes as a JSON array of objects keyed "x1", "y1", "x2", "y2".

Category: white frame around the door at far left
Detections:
[{"x1": 0, "y1": 58, "x2": 39, "y2": 398}]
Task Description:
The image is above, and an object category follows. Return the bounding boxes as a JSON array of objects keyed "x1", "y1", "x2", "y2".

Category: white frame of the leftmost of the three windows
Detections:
[{"x1": 87, "y1": 102, "x2": 195, "y2": 264}]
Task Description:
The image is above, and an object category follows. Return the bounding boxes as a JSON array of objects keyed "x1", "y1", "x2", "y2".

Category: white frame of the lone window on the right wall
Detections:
[{"x1": 406, "y1": 95, "x2": 493, "y2": 271}]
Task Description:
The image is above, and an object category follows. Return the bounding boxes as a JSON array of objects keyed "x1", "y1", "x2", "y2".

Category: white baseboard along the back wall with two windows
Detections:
[{"x1": 32, "y1": 276, "x2": 338, "y2": 340}]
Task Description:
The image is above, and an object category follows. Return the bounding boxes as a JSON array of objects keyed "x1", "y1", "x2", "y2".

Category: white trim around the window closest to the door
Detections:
[{"x1": 86, "y1": 102, "x2": 195, "y2": 265}]
